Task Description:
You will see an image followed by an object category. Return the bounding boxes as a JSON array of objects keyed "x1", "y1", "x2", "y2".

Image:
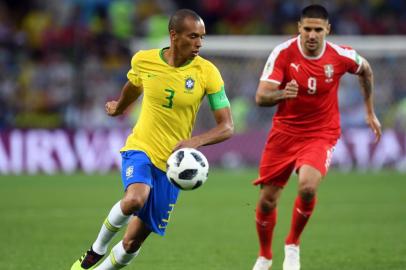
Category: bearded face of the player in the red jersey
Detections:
[{"x1": 299, "y1": 18, "x2": 330, "y2": 56}]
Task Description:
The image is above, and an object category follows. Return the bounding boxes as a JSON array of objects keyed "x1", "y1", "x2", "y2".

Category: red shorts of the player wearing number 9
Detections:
[{"x1": 254, "y1": 130, "x2": 337, "y2": 187}]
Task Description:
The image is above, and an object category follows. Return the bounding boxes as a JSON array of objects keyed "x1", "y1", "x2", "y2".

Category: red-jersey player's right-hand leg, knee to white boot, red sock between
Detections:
[{"x1": 283, "y1": 165, "x2": 322, "y2": 270}]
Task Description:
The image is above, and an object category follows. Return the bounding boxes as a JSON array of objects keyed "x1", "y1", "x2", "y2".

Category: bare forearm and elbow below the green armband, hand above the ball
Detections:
[{"x1": 174, "y1": 107, "x2": 234, "y2": 151}]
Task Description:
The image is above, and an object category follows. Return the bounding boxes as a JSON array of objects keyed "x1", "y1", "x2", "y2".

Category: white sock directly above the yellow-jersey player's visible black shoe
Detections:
[{"x1": 92, "y1": 201, "x2": 131, "y2": 255}]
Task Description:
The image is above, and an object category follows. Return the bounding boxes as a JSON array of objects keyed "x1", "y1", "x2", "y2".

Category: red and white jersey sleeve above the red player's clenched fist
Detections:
[{"x1": 260, "y1": 46, "x2": 286, "y2": 84}]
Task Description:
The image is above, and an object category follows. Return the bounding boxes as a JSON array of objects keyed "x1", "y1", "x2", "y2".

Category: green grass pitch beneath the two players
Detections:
[{"x1": 0, "y1": 170, "x2": 406, "y2": 270}]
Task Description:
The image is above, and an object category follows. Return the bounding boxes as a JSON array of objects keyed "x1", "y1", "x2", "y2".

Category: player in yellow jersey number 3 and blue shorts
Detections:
[{"x1": 71, "y1": 9, "x2": 233, "y2": 270}]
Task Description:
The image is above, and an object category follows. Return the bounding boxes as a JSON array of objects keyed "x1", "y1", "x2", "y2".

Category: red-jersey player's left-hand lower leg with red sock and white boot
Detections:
[{"x1": 253, "y1": 184, "x2": 282, "y2": 270}]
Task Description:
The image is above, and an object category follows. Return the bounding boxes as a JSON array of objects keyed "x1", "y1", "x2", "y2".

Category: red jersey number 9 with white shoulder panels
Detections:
[{"x1": 261, "y1": 36, "x2": 362, "y2": 139}]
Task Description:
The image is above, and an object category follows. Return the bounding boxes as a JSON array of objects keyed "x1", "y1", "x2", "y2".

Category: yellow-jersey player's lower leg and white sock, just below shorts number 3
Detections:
[{"x1": 95, "y1": 217, "x2": 151, "y2": 270}]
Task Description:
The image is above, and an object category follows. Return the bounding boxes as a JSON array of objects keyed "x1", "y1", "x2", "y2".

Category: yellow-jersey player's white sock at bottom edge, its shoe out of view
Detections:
[{"x1": 94, "y1": 241, "x2": 140, "y2": 270}]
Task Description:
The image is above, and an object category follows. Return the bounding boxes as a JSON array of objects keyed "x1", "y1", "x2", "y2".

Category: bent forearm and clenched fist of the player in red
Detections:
[{"x1": 255, "y1": 80, "x2": 299, "y2": 106}]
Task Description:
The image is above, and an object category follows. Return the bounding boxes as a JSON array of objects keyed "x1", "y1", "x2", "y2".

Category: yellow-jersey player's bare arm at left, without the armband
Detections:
[{"x1": 105, "y1": 81, "x2": 142, "y2": 116}]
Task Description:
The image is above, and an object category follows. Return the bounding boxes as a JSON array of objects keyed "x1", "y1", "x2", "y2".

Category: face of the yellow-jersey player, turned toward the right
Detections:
[{"x1": 173, "y1": 17, "x2": 206, "y2": 59}]
